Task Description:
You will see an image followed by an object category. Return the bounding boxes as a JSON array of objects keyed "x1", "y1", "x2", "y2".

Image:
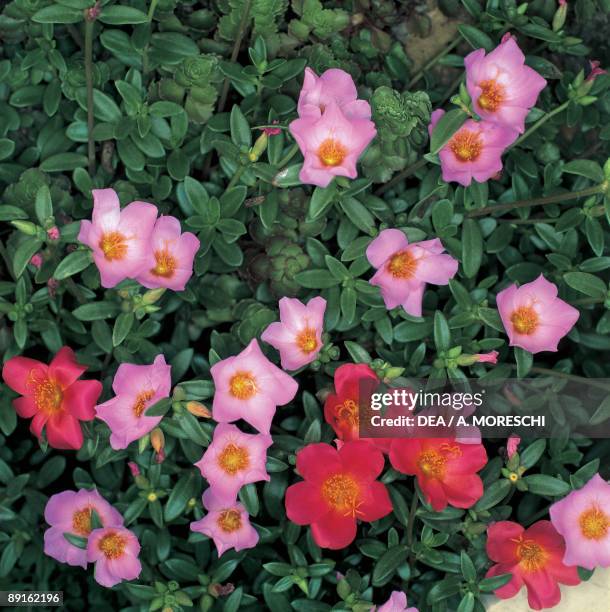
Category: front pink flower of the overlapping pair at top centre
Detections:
[{"x1": 288, "y1": 102, "x2": 377, "y2": 187}]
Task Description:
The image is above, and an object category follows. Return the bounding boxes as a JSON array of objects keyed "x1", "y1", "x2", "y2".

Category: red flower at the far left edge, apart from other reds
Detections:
[{"x1": 2, "y1": 346, "x2": 102, "y2": 449}]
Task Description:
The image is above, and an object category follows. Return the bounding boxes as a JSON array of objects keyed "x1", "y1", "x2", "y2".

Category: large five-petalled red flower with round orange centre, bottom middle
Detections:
[{"x1": 286, "y1": 441, "x2": 392, "y2": 549}]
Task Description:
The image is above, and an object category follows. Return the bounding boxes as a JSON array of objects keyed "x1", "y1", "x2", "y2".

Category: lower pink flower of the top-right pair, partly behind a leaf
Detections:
[{"x1": 428, "y1": 109, "x2": 518, "y2": 187}]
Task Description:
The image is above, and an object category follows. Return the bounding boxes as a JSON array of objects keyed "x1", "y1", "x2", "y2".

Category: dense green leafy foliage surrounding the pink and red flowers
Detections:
[{"x1": 0, "y1": 0, "x2": 610, "y2": 612}]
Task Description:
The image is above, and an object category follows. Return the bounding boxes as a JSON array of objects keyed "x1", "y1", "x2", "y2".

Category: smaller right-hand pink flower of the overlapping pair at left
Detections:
[{"x1": 136, "y1": 216, "x2": 200, "y2": 291}]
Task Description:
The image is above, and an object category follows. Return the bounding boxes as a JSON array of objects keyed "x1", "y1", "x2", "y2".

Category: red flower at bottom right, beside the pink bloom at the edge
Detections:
[{"x1": 487, "y1": 521, "x2": 580, "y2": 610}]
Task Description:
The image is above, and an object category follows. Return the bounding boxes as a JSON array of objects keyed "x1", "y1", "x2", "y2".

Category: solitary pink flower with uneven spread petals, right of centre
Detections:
[{"x1": 366, "y1": 229, "x2": 458, "y2": 317}]
